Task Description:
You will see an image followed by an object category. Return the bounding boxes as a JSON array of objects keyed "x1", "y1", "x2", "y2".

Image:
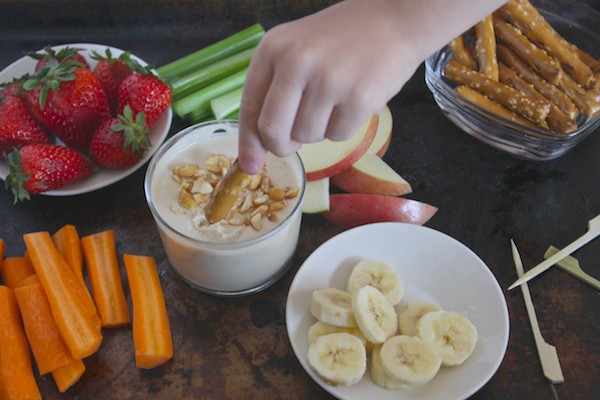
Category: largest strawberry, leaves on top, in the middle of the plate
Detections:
[{"x1": 23, "y1": 60, "x2": 110, "y2": 150}]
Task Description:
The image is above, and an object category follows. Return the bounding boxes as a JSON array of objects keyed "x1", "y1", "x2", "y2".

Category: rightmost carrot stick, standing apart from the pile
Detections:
[{"x1": 123, "y1": 254, "x2": 173, "y2": 368}]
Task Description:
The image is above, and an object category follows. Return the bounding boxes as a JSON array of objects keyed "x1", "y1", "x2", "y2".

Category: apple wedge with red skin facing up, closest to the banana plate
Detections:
[{"x1": 323, "y1": 193, "x2": 438, "y2": 229}]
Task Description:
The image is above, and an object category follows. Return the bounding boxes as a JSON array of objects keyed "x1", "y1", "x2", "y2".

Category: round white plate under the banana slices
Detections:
[{"x1": 286, "y1": 222, "x2": 509, "y2": 400}]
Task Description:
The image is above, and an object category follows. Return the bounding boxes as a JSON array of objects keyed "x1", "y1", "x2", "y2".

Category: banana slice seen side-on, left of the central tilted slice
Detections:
[{"x1": 310, "y1": 288, "x2": 357, "y2": 328}]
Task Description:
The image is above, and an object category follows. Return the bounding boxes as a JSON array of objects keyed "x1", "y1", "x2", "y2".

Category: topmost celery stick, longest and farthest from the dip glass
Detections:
[{"x1": 156, "y1": 24, "x2": 265, "y2": 80}]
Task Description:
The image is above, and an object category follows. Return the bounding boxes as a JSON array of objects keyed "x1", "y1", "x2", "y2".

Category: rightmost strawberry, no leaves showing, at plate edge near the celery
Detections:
[{"x1": 119, "y1": 72, "x2": 171, "y2": 128}]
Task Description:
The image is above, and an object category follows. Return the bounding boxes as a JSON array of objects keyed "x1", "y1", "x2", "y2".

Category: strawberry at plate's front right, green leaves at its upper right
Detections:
[{"x1": 89, "y1": 106, "x2": 150, "y2": 169}]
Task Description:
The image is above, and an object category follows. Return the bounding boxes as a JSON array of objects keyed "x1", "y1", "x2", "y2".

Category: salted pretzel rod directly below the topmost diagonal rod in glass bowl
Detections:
[{"x1": 493, "y1": 17, "x2": 563, "y2": 85}]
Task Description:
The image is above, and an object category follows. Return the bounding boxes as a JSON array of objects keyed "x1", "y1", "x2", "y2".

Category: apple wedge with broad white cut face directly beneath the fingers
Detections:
[{"x1": 298, "y1": 115, "x2": 379, "y2": 181}]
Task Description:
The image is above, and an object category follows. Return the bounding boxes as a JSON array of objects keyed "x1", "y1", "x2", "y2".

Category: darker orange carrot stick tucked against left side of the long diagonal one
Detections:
[{"x1": 14, "y1": 277, "x2": 75, "y2": 375}]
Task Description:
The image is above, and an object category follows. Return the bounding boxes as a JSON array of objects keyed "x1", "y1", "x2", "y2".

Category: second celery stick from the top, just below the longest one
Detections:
[{"x1": 171, "y1": 47, "x2": 256, "y2": 101}]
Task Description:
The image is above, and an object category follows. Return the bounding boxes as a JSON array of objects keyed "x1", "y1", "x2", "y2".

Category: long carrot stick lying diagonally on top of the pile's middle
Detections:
[{"x1": 23, "y1": 231, "x2": 102, "y2": 359}]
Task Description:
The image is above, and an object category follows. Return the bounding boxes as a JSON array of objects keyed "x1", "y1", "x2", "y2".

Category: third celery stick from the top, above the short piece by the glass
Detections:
[{"x1": 172, "y1": 68, "x2": 248, "y2": 120}]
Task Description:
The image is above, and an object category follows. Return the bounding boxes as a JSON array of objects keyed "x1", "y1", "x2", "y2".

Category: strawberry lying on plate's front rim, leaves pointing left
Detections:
[{"x1": 4, "y1": 143, "x2": 93, "y2": 203}]
